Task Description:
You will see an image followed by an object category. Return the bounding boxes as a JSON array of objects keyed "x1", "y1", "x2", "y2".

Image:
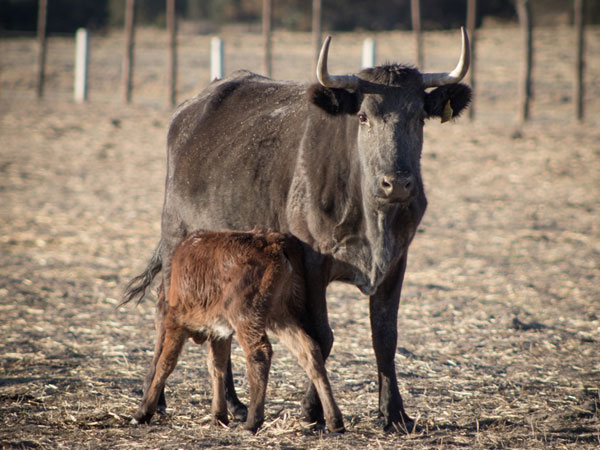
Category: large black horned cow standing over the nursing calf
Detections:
[{"x1": 123, "y1": 30, "x2": 471, "y2": 430}]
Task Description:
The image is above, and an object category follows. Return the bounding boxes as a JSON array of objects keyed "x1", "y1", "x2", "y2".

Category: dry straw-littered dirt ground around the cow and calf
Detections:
[{"x1": 0, "y1": 28, "x2": 600, "y2": 449}]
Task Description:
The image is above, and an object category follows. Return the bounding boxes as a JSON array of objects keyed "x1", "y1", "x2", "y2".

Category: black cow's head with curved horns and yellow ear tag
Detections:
[{"x1": 308, "y1": 29, "x2": 471, "y2": 207}]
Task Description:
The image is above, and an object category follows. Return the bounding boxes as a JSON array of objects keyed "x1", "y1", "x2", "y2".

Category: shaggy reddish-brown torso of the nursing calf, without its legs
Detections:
[{"x1": 168, "y1": 231, "x2": 304, "y2": 337}]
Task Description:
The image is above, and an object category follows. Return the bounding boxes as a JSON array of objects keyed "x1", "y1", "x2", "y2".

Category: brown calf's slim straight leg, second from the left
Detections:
[{"x1": 208, "y1": 337, "x2": 231, "y2": 425}]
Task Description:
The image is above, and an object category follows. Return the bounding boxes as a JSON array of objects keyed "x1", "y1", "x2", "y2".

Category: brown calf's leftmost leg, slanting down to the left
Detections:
[{"x1": 131, "y1": 326, "x2": 186, "y2": 424}]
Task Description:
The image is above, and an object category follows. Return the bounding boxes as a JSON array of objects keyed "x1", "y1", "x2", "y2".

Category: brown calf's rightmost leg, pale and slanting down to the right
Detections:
[{"x1": 277, "y1": 324, "x2": 344, "y2": 433}]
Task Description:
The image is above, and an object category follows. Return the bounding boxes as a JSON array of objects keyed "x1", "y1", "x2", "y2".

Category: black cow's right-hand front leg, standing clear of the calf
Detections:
[{"x1": 369, "y1": 255, "x2": 414, "y2": 433}]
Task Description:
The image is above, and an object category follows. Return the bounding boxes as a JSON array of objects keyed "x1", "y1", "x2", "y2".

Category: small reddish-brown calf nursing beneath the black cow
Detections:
[{"x1": 132, "y1": 232, "x2": 344, "y2": 431}]
